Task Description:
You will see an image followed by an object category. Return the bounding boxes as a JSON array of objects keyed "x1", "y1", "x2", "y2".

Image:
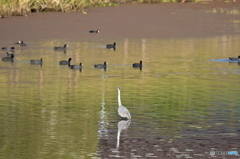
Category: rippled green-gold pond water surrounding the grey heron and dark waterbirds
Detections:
[{"x1": 0, "y1": 36, "x2": 240, "y2": 159}]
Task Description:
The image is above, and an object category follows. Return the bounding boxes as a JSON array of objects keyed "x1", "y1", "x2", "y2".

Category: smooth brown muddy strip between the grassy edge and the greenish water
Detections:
[{"x1": 0, "y1": 2, "x2": 240, "y2": 44}]
